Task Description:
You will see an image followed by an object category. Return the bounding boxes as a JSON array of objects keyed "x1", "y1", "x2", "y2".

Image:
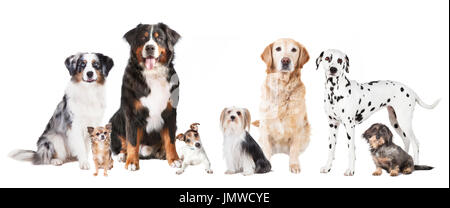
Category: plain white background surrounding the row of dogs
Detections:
[{"x1": 0, "y1": 0, "x2": 449, "y2": 187}]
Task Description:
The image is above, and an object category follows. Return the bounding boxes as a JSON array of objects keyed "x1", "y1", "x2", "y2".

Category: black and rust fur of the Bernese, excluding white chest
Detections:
[{"x1": 110, "y1": 23, "x2": 180, "y2": 170}]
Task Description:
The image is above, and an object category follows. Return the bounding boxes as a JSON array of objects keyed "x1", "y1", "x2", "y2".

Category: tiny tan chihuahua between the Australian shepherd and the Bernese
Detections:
[{"x1": 87, "y1": 124, "x2": 114, "y2": 176}]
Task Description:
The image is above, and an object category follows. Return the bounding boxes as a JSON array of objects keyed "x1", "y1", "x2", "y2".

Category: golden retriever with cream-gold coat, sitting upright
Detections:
[{"x1": 253, "y1": 39, "x2": 310, "y2": 173}]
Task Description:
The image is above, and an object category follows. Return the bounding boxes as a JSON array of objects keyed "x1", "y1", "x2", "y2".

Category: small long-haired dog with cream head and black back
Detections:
[{"x1": 220, "y1": 107, "x2": 272, "y2": 175}]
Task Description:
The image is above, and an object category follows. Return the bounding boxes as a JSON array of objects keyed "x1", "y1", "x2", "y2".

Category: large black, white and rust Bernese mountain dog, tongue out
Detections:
[{"x1": 110, "y1": 23, "x2": 181, "y2": 171}]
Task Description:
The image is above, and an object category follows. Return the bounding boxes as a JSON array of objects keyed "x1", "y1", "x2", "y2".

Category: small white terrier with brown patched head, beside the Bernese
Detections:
[{"x1": 177, "y1": 123, "x2": 213, "y2": 175}]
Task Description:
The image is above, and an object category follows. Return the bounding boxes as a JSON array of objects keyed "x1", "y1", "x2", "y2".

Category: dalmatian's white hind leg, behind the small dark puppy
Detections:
[{"x1": 395, "y1": 108, "x2": 419, "y2": 164}]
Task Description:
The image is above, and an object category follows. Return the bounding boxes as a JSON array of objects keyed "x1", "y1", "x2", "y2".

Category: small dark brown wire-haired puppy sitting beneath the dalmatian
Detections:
[{"x1": 363, "y1": 123, "x2": 433, "y2": 176}]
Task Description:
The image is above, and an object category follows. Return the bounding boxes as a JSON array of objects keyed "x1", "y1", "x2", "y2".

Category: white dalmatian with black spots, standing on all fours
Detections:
[{"x1": 316, "y1": 49, "x2": 440, "y2": 176}]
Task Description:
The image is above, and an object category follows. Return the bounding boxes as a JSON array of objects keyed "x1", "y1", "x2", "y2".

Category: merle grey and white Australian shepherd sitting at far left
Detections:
[{"x1": 10, "y1": 53, "x2": 114, "y2": 169}]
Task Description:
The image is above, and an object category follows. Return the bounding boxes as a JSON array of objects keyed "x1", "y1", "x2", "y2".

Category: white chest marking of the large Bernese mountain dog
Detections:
[{"x1": 139, "y1": 66, "x2": 171, "y2": 133}]
